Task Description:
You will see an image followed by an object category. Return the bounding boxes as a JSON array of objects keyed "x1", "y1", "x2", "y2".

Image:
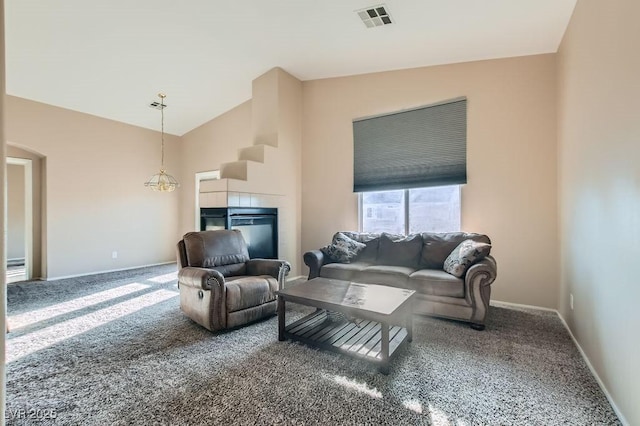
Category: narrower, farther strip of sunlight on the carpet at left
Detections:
[{"x1": 8, "y1": 283, "x2": 150, "y2": 330}]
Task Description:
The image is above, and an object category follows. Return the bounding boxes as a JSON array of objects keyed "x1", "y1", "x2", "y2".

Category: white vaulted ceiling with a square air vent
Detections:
[{"x1": 5, "y1": 0, "x2": 576, "y2": 135}]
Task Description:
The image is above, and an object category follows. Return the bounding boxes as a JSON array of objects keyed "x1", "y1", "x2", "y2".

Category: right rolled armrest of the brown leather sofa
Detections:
[{"x1": 464, "y1": 256, "x2": 498, "y2": 329}]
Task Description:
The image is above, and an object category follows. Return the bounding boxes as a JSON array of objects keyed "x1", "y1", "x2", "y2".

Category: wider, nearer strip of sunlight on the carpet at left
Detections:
[{"x1": 6, "y1": 290, "x2": 178, "y2": 363}]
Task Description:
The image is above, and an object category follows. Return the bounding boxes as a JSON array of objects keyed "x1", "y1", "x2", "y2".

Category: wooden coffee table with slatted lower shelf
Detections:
[{"x1": 276, "y1": 278, "x2": 415, "y2": 374}]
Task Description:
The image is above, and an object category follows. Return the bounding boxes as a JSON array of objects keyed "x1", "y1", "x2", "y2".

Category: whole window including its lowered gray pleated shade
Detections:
[{"x1": 353, "y1": 97, "x2": 467, "y2": 235}]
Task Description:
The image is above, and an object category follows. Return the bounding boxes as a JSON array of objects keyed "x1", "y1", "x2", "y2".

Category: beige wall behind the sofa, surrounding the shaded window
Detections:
[{"x1": 302, "y1": 55, "x2": 558, "y2": 308}]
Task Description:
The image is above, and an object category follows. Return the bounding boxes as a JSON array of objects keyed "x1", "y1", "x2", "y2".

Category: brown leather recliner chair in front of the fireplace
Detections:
[{"x1": 177, "y1": 230, "x2": 291, "y2": 331}]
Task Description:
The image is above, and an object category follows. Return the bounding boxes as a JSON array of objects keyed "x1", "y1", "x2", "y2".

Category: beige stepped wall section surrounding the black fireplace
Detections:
[{"x1": 180, "y1": 68, "x2": 302, "y2": 276}]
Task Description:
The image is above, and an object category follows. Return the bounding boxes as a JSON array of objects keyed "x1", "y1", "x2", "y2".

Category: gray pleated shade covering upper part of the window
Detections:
[{"x1": 353, "y1": 98, "x2": 467, "y2": 192}]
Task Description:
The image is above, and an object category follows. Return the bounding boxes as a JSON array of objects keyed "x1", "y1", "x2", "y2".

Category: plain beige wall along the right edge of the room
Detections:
[{"x1": 558, "y1": 0, "x2": 640, "y2": 425}]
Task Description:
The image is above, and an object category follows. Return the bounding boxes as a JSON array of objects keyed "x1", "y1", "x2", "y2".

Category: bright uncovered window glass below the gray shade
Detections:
[{"x1": 359, "y1": 185, "x2": 460, "y2": 234}]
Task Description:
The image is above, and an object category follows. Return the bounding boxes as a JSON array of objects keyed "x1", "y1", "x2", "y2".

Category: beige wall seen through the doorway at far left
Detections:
[{"x1": 7, "y1": 164, "x2": 26, "y2": 260}]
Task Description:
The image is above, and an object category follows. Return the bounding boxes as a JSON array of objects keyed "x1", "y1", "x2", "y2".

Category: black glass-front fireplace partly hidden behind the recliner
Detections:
[{"x1": 200, "y1": 207, "x2": 278, "y2": 259}]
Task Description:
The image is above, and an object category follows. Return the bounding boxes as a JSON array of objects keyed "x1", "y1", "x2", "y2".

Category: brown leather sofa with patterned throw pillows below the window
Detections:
[{"x1": 304, "y1": 231, "x2": 497, "y2": 330}]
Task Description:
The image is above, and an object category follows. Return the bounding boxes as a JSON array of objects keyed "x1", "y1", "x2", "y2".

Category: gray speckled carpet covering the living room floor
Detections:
[{"x1": 6, "y1": 265, "x2": 620, "y2": 425}]
